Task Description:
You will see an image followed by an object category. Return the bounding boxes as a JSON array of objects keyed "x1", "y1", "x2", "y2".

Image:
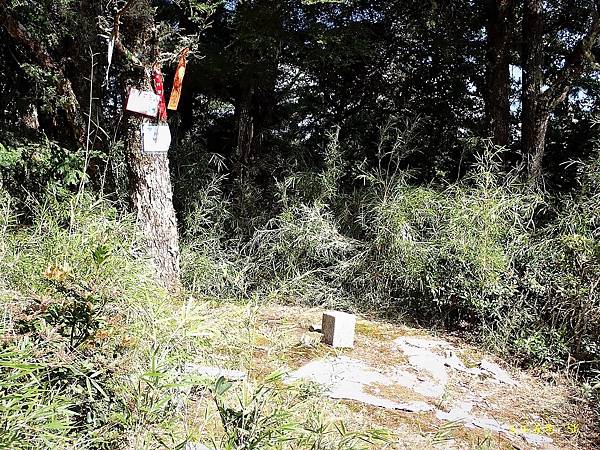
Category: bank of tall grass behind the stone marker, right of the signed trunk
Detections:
[{"x1": 179, "y1": 137, "x2": 600, "y2": 380}]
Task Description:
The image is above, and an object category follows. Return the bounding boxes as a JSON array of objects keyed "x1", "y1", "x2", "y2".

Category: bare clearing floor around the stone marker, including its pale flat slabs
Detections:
[{"x1": 185, "y1": 303, "x2": 600, "y2": 450}]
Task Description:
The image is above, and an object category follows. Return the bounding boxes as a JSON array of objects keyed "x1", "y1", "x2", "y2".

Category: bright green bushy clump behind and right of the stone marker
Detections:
[{"x1": 357, "y1": 149, "x2": 539, "y2": 323}]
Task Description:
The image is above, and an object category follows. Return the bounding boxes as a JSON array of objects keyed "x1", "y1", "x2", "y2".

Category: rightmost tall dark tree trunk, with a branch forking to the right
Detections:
[{"x1": 521, "y1": 0, "x2": 549, "y2": 182}]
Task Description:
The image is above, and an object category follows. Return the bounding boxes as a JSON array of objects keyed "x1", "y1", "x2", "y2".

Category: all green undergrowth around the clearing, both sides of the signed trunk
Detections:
[{"x1": 0, "y1": 133, "x2": 600, "y2": 449}]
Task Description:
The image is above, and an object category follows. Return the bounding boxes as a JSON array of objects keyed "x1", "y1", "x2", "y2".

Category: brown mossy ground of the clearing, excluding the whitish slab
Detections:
[{"x1": 186, "y1": 304, "x2": 600, "y2": 449}]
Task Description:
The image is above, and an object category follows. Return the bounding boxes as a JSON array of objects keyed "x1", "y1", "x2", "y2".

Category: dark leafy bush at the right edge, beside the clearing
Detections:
[{"x1": 521, "y1": 158, "x2": 600, "y2": 364}]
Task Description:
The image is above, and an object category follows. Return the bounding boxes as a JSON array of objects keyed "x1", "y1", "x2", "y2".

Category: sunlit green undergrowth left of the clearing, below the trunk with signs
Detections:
[{"x1": 0, "y1": 191, "x2": 386, "y2": 450}]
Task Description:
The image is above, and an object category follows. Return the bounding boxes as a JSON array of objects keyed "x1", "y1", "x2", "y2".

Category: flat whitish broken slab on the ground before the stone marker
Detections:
[{"x1": 284, "y1": 332, "x2": 540, "y2": 445}]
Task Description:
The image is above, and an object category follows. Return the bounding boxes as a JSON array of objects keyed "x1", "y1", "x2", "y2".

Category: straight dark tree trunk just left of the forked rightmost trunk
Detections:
[{"x1": 485, "y1": 0, "x2": 514, "y2": 146}]
